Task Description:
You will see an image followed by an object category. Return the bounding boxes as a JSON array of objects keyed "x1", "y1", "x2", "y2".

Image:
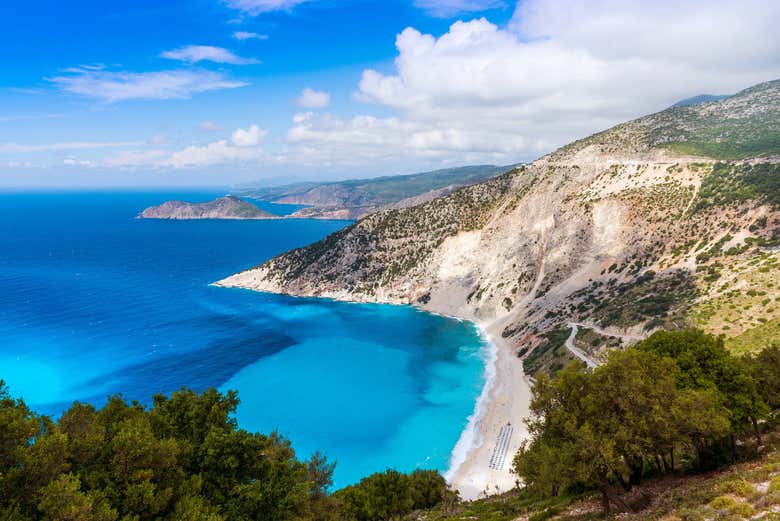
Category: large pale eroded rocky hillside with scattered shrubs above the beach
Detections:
[{"x1": 220, "y1": 81, "x2": 780, "y2": 372}]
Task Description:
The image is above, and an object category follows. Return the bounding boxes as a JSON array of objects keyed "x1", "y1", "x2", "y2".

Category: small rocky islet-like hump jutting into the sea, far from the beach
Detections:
[{"x1": 138, "y1": 195, "x2": 279, "y2": 220}]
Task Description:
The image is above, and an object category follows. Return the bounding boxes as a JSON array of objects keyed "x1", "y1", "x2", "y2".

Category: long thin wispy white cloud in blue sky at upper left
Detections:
[{"x1": 48, "y1": 68, "x2": 247, "y2": 103}]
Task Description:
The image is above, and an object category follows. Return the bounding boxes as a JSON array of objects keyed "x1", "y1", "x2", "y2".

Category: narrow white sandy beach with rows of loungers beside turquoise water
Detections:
[{"x1": 445, "y1": 324, "x2": 531, "y2": 501}]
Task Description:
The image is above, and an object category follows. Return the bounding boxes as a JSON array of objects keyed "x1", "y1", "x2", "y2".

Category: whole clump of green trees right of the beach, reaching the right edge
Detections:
[{"x1": 514, "y1": 330, "x2": 780, "y2": 511}]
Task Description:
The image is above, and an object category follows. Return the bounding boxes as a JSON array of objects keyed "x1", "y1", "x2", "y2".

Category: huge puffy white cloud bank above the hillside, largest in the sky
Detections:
[{"x1": 288, "y1": 0, "x2": 780, "y2": 168}]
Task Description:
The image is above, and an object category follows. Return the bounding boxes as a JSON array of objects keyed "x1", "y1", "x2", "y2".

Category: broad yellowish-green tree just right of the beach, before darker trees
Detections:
[{"x1": 513, "y1": 349, "x2": 728, "y2": 511}]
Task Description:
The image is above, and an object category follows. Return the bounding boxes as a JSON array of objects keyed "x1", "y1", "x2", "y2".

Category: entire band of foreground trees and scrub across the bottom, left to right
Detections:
[{"x1": 0, "y1": 329, "x2": 780, "y2": 521}]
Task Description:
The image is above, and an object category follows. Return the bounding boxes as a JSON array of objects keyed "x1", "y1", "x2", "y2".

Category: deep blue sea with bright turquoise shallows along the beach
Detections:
[{"x1": 0, "y1": 191, "x2": 486, "y2": 487}]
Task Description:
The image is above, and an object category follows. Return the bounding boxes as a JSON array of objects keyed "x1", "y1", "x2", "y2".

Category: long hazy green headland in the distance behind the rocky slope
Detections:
[{"x1": 242, "y1": 165, "x2": 512, "y2": 219}]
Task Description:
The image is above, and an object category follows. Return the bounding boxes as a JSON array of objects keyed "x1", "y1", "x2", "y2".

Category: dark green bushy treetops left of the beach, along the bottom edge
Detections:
[{"x1": 0, "y1": 382, "x2": 446, "y2": 521}]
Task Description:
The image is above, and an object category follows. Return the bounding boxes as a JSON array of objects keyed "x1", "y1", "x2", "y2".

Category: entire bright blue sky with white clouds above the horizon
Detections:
[{"x1": 0, "y1": 0, "x2": 780, "y2": 188}]
